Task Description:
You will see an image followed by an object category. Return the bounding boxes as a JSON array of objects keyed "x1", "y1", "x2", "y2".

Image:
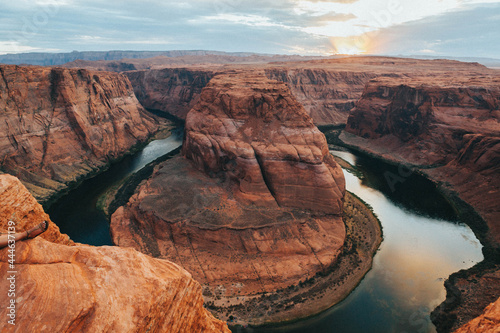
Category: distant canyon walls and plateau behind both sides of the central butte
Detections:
[{"x1": 106, "y1": 56, "x2": 490, "y2": 125}]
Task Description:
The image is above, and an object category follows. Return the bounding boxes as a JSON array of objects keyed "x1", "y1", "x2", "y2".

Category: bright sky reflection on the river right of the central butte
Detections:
[{"x1": 248, "y1": 152, "x2": 483, "y2": 333}]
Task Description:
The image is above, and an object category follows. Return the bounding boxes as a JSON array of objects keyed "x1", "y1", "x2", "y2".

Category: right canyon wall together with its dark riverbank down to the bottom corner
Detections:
[{"x1": 340, "y1": 74, "x2": 500, "y2": 332}]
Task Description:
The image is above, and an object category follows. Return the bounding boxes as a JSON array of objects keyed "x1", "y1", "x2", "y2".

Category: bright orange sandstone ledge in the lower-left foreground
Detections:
[{"x1": 0, "y1": 174, "x2": 230, "y2": 333}]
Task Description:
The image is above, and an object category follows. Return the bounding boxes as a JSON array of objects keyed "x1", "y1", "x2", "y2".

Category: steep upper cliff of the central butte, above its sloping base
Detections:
[{"x1": 183, "y1": 73, "x2": 345, "y2": 214}]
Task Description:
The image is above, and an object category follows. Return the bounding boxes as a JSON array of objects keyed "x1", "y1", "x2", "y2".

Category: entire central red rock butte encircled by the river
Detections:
[{"x1": 111, "y1": 73, "x2": 345, "y2": 296}]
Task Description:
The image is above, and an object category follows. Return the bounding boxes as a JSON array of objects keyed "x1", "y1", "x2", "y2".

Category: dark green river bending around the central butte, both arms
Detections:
[{"x1": 47, "y1": 133, "x2": 483, "y2": 333}]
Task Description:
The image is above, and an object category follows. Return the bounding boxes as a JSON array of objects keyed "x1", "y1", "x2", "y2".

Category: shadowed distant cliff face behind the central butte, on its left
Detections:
[{"x1": 124, "y1": 68, "x2": 214, "y2": 119}]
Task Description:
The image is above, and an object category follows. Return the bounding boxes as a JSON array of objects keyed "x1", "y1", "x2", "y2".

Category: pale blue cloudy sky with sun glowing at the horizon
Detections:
[{"x1": 0, "y1": 0, "x2": 500, "y2": 58}]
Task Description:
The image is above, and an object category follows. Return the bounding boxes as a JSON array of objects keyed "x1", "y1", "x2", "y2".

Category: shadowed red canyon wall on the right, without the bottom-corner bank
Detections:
[{"x1": 341, "y1": 74, "x2": 500, "y2": 246}]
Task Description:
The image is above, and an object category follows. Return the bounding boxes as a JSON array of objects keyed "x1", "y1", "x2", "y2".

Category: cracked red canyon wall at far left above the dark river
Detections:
[{"x1": 0, "y1": 66, "x2": 158, "y2": 200}]
